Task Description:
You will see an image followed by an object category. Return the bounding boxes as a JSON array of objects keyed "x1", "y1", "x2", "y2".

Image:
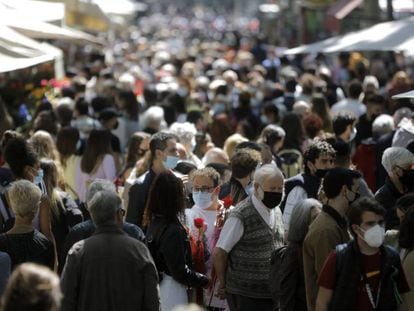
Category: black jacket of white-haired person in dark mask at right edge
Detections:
[{"x1": 375, "y1": 177, "x2": 404, "y2": 230}]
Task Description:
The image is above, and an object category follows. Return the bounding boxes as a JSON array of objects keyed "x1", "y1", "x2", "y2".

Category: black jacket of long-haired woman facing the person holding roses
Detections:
[{"x1": 147, "y1": 216, "x2": 208, "y2": 287}]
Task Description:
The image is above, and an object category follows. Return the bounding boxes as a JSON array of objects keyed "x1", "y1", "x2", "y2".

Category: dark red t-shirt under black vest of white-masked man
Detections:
[{"x1": 318, "y1": 251, "x2": 409, "y2": 311}]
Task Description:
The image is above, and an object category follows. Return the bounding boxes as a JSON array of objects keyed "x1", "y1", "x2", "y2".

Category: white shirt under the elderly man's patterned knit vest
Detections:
[{"x1": 216, "y1": 194, "x2": 284, "y2": 253}]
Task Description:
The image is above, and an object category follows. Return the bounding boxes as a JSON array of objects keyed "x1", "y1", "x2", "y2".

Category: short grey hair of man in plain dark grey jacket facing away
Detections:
[{"x1": 88, "y1": 191, "x2": 122, "y2": 226}]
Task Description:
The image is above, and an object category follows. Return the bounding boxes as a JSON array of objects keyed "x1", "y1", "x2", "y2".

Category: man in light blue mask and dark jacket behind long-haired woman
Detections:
[{"x1": 126, "y1": 132, "x2": 179, "y2": 226}]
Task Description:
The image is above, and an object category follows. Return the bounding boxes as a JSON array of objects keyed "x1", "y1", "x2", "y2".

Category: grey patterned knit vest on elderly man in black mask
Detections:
[{"x1": 226, "y1": 198, "x2": 283, "y2": 298}]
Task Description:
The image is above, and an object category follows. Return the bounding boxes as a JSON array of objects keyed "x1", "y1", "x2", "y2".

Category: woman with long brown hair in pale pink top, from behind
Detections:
[{"x1": 75, "y1": 130, "x2": 116, "y2": 202}]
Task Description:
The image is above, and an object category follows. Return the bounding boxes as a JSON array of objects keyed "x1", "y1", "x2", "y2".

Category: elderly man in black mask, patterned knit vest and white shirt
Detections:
[{"x1": 214, "y1": 164, "x2": 284, "y2": 311}]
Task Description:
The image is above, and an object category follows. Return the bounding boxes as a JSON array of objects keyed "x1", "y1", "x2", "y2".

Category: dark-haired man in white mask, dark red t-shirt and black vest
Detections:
[{"x1": 316, "y1": 198, "x2": 409, "y2": 311}]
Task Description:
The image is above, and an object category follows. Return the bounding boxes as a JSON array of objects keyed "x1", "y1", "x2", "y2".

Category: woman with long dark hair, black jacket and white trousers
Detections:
[{"x1": 144, "y1": 172, "x2": 209, "y2": 311}]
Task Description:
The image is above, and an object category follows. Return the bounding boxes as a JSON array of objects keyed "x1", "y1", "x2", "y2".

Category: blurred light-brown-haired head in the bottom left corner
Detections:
[{"x1": 0, "y1": 263, "x2": 62, "y2": 311}]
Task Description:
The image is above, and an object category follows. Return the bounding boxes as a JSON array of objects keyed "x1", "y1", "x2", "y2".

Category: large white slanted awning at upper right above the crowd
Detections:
[{"x1": 284, "y1": 16, "x2": 414, "y2": 54}]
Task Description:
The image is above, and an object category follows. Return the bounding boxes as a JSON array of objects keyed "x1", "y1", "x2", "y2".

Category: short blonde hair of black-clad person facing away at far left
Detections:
[{"x1": 8, "y1": 180, "x2": 42, "y2": 217}]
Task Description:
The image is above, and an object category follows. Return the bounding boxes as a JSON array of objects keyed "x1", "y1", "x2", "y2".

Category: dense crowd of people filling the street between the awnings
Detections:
[{"x1": 0, "y1": 6, "x2": 414, "y2": 311}]
